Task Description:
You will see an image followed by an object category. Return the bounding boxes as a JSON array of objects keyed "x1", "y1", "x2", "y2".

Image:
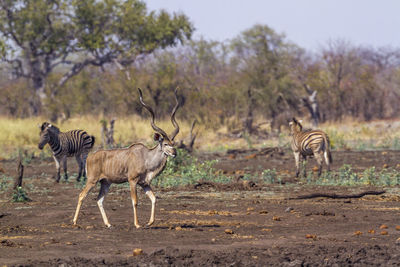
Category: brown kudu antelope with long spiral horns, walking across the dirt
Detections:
[{"x1": 73, "y1": 89, "x2": 179, "y2": 228}]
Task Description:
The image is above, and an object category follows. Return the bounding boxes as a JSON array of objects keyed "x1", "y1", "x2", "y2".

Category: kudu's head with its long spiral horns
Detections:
[{"x1": 138, "y1": 88, "x2": 179, "y2": 157}]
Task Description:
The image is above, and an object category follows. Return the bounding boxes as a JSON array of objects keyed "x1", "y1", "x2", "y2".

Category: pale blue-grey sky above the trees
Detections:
[{"x1": 145, "y1": 0, "x2": 400, "y2": 51}]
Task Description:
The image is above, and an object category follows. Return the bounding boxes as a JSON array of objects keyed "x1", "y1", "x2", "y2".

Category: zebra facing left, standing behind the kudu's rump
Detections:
[{"x1": 39, "y1": 122, "x2": 95, "y2": 183}]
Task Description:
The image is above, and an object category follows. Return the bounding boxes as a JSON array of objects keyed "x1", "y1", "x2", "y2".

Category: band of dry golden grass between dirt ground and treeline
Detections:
[{"x1": 0, "y1": 115, "x2": 400, "y2": 158}]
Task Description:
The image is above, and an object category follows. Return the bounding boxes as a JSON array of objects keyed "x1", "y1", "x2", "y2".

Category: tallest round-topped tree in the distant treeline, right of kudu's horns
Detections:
[{"x1": 232, "y1": 25, "x2": 296, "y2": 133}]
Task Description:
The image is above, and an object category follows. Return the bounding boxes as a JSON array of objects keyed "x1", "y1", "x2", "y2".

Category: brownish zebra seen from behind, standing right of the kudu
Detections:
[{"x1": 289, "y1": 118, "x2": 332, "y2": 177}]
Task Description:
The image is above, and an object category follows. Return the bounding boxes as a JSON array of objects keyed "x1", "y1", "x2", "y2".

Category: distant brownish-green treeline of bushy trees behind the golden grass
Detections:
[{"x1": 0, "y1": 25, "x2": 400, "y2": 131}]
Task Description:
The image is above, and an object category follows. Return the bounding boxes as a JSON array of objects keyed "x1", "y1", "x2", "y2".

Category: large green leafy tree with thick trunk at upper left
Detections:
[{"x1": 0, "y1": 0, "x2": 193, "y2": 115}]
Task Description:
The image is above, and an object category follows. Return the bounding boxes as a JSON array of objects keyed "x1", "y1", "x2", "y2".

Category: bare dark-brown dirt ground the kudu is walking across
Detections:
[{"x1": 0, "y1": 149, "x2": 400, "y2": 266}]
